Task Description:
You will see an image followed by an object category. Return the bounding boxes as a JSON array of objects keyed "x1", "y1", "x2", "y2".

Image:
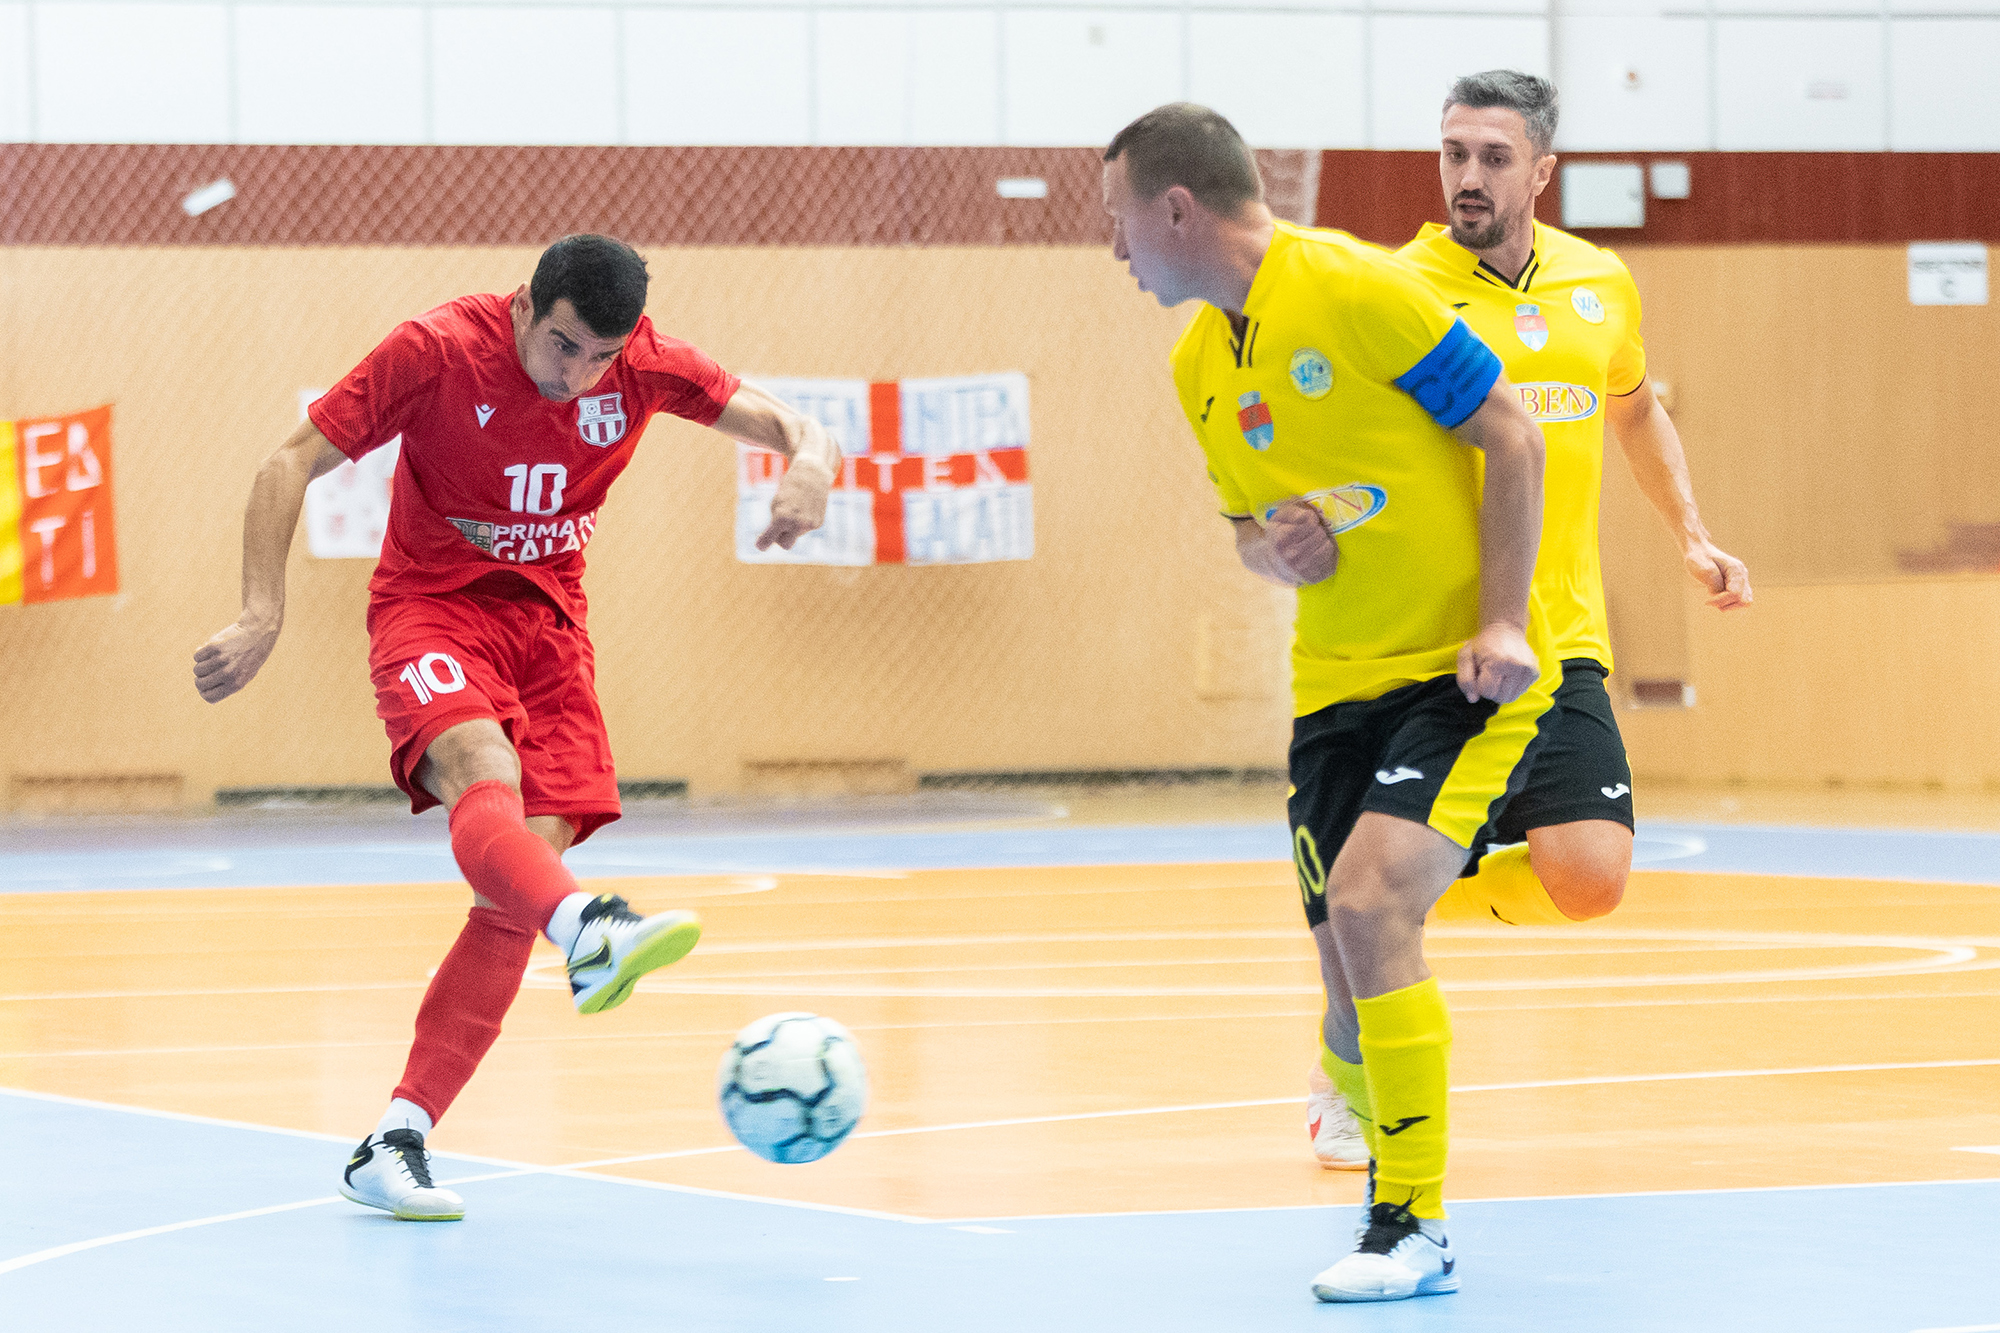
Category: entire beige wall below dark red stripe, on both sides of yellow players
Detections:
[{"x1": 0, "y1": 246, "x2": 2000, "y2": 797}]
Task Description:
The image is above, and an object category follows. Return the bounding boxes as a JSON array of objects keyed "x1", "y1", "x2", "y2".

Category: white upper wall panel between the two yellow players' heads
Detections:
[{"x1": 1188, "y1": 14, "x2": 1366, "y2": 148}]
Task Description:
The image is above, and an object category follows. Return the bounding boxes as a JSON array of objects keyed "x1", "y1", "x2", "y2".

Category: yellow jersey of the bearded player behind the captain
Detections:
[{"x1": 1398, "y1": 222, "x2": 1646, "y2": 671}]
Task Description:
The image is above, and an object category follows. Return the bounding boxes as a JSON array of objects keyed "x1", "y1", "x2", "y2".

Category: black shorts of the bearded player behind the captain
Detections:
[{"x1": 1478, "y1": 656, "x2": 1632, "y2": 847}]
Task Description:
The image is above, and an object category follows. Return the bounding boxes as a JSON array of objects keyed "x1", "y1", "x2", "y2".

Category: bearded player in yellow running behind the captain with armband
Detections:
[{"x1": 1306, "y1": 70, "x2": 1750, "y2": 1169}]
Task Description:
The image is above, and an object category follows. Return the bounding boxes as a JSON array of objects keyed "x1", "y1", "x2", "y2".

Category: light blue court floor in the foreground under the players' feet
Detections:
[{"x1": 0, "y1": 1095, "x2": 2000, "y2": 1333}]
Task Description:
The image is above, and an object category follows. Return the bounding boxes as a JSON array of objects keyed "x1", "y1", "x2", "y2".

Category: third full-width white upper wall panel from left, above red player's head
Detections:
[{"x1": 430, "y1": 6, "x2": 618, "y2": 144}]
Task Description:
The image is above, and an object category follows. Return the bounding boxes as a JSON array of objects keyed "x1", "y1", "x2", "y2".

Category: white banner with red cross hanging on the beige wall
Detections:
[{"x1": 736, "y1": 372, "x2": 1034, "y2": 564}]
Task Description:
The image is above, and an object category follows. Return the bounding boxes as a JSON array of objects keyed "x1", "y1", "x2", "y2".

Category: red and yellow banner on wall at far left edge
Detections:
[{"x1": 0, "y1": 406, "x2": 118, "y2": 604}]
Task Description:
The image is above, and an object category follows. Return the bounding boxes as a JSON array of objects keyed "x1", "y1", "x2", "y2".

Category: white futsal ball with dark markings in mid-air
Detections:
[{"x1": 716, "y1": 1013, "x2": 868, "y2": 1165}]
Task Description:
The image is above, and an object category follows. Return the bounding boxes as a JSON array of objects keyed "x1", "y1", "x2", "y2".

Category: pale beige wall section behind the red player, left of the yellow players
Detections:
[{"x1": 0, "y1": 246, "x2": 1290, "y2": 795}]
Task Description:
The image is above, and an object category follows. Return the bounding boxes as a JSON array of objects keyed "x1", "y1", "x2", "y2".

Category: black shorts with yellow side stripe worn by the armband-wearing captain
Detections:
[{"x1": 1286, "y1": 677, "x2": 1554, "y2": 925}]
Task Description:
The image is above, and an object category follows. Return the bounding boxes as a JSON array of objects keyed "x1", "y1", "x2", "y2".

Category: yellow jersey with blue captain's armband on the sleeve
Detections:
[{"x1": 1174, "y1": 222, "x2": 1528, "y2": 717}]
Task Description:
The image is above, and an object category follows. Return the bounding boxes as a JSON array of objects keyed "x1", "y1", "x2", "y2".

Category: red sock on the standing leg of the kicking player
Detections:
[{"x1": 392, "y1": 904, "x2": 534, "y2": 1123}]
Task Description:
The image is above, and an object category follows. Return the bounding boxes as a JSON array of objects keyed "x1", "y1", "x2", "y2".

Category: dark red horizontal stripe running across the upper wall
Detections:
[{"x1": 0, "y1": 144, "x2": 2000, "y2": 246}]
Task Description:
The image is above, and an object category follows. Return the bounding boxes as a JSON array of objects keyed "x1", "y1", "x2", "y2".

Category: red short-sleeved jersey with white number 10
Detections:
[{"x1": 308, "y1": 296, "x2": 738, "y2": 622}]
